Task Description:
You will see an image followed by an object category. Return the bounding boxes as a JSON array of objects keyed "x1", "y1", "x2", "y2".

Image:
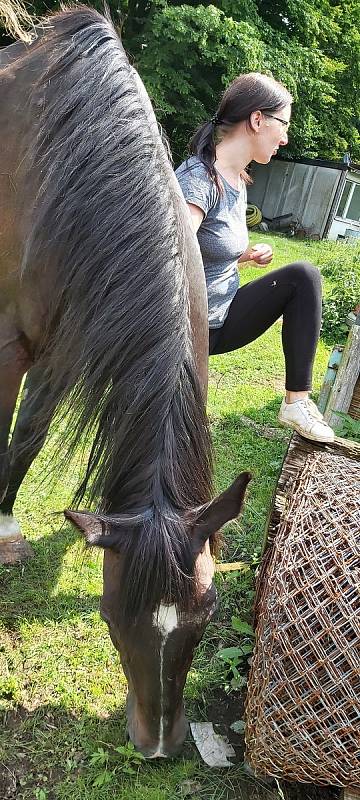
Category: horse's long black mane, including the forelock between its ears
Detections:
[{"x1": 16, "y1": 6, "x2": 211, "y2": 616}]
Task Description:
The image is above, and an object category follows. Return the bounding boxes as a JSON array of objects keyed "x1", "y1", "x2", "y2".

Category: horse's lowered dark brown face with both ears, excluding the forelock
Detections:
[{"x1": 65, "y1": 472, "x2": 250, "y2": 758}]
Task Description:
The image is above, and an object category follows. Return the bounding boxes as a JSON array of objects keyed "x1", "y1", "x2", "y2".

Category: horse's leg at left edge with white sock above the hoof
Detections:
[{"x1": 0, "y1": 314, "x2": 30, "y2": 563}]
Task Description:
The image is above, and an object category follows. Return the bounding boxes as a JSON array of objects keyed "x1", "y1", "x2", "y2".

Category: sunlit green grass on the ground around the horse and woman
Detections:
[{"x1": 0, "y1": 234, "x2": 344, "y2": 800}]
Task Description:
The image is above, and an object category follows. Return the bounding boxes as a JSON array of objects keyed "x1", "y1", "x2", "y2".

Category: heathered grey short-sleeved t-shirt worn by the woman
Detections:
[{"x1": 175, "y1": 156, "x2": 249, "y2": 328}]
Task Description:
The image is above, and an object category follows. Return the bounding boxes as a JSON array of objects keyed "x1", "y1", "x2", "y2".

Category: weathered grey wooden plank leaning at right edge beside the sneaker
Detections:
[{"x1": 324, "y1": 324, "x2": 360, "y2": 427}]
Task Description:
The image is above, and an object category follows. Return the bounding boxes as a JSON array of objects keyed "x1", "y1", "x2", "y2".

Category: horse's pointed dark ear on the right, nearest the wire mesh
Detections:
[{"x1": 192, "y1": 472, "x2": 252, "y2": 555}]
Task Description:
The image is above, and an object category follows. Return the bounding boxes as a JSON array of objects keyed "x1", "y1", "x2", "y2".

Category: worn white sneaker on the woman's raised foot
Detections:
[{"x1": 278, "y1": 397, "x2": 335, "y2": 442}]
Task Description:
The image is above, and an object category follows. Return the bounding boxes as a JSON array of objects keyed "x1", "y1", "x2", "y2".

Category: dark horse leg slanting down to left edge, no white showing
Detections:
[{"x1": 0, "y1": 364, "x2": 49, "y2": 514}]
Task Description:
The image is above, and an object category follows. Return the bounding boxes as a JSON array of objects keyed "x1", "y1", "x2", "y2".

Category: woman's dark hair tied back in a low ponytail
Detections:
[{"x1": 189, "y1": 72, "x2": 293, "y2": 193}]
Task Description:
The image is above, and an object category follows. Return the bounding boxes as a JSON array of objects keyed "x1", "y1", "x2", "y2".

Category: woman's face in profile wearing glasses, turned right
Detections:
[{"x1": 250, "y1": 104, "x2": 291, "y2": 164}]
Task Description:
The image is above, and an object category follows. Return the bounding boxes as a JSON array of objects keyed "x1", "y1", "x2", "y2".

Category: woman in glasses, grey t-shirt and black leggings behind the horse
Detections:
[{"x1": 176, "y1": 73, "x2": 334, "y2": 442}]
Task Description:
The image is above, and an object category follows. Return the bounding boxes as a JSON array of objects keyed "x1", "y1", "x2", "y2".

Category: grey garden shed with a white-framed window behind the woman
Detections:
[{"x1": 248, "y1": 155, "x2": 360, "y2": 240}]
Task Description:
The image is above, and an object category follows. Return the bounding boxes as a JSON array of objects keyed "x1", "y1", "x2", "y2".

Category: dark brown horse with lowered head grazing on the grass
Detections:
[{"x1": 0, "y1": 0, "x2": 250, "y2": 758}]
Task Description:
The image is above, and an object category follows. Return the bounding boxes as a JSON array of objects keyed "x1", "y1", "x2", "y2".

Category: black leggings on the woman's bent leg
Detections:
[{"x1": 210, "y1": 261, "x2": 321, "y2": 392}]
